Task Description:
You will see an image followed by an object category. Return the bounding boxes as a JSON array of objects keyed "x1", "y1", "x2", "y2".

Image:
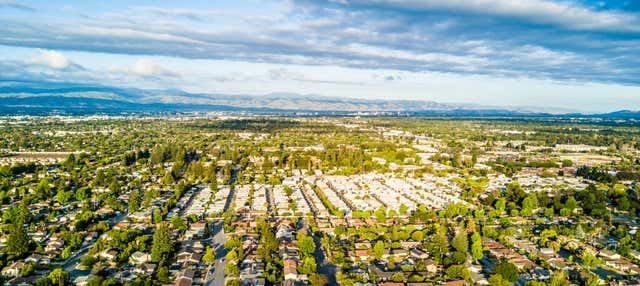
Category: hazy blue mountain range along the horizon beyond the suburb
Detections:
[{"x1": 0, "y1": 81, "x2": 640, "y2": 119}]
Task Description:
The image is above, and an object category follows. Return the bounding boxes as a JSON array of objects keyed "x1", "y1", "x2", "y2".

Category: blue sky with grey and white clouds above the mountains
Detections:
[{"x1": 0, "y1": 0, "x2": 640, "y2": 112}]
